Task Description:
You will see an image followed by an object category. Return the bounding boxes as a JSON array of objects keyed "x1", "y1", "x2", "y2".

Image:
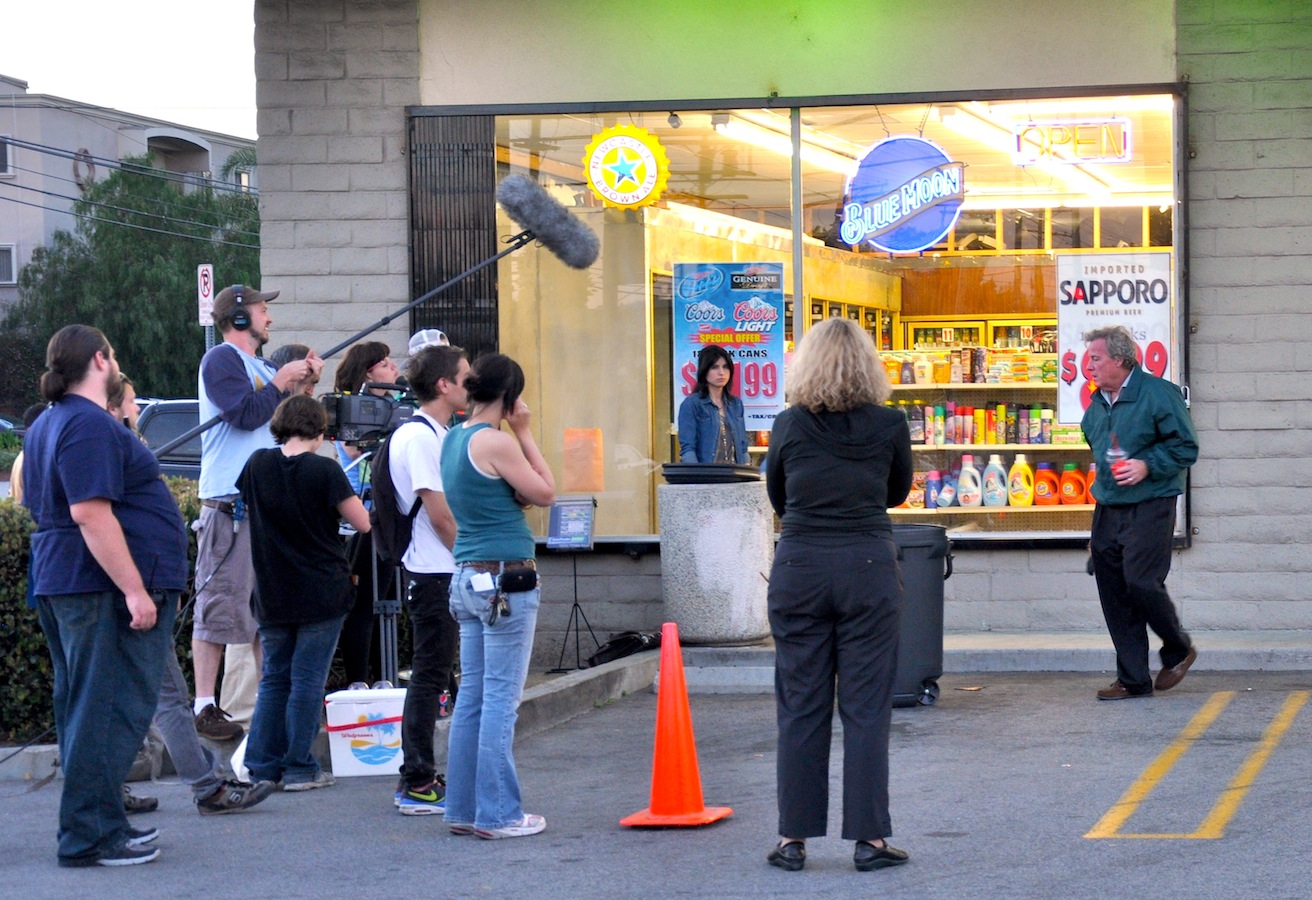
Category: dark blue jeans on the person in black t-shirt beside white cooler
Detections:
[{"x1": 245, "y1": 615, "x2": 346, "y2": 785}]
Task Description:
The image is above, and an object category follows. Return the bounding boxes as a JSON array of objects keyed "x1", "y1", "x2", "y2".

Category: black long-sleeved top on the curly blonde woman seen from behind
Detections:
[{"x1": 765, "y1": 404, "x2": 912, "y2": 538}]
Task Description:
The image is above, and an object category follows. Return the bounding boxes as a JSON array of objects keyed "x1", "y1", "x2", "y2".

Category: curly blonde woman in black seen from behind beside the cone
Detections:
[{"x1": 765, "y1": 319, "x2": 912, "y2": 871}]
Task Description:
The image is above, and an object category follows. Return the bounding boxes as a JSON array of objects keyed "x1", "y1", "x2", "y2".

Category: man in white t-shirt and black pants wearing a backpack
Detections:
[{"x1": 375, "y1": 346, "x2": 470, "y2": 816}]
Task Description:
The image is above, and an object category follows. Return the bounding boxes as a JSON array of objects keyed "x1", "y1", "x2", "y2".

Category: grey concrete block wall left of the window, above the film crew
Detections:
[{"x1": 255, "y1": 0, "x2": 420, "y2": 384}]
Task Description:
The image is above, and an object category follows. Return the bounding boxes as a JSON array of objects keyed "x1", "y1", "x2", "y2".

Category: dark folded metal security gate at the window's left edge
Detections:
[{"x1": 409, "y1": 115, "x2": 500, "y2": 359}]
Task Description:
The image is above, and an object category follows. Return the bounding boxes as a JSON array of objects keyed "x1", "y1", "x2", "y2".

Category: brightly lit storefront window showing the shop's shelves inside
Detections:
[{"x1": 459, "y1": 96, "x2": 1179, "y2": 539}]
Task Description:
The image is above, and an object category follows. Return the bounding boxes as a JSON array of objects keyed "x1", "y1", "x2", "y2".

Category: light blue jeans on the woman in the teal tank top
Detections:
[{"x1": 446, "y1": 568, "x2": 542, "y2": 828}]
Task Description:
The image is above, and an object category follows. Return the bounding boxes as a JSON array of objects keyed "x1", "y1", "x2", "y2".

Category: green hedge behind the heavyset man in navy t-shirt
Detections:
[{"x1": 0, "y1": 478, "x2": 201, "y2": 743}]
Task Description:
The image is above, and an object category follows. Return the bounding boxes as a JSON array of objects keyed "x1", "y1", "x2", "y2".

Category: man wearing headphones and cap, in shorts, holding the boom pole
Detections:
[{"x1": 192, "y1": 285, "x2": 323, "y2": 740}]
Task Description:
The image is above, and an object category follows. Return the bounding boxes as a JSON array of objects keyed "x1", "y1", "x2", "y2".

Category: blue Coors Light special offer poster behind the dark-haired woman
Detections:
[{"x1": 672, "y1": 262, "x2": 783, "y2": 432}]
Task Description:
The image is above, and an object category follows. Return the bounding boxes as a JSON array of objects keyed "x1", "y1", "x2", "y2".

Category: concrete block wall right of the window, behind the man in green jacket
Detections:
[{"x1": 1168, "y1": 0, "x2": 1312, "y2": 630}]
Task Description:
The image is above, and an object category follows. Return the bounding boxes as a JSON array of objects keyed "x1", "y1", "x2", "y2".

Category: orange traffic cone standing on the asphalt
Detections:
[{"x1": 619, "y1": 622, "x2": 733, "y2": 825}]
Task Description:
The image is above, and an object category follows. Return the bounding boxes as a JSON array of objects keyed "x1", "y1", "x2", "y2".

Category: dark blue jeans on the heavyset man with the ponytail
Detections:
[{"x1": 37, "y1": 590, "x2": 177, "y2": 859}]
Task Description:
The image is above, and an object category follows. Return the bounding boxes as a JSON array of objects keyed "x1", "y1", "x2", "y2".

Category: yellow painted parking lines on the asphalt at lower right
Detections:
[{"x1": 1085, "y1": 690, "x2": 1309, "y2": 840}]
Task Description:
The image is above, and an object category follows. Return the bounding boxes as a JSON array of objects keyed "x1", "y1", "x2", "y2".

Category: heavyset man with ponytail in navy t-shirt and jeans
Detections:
[{"x1": 24, "y1": 325, "x2": 186, "y2": 866}]
